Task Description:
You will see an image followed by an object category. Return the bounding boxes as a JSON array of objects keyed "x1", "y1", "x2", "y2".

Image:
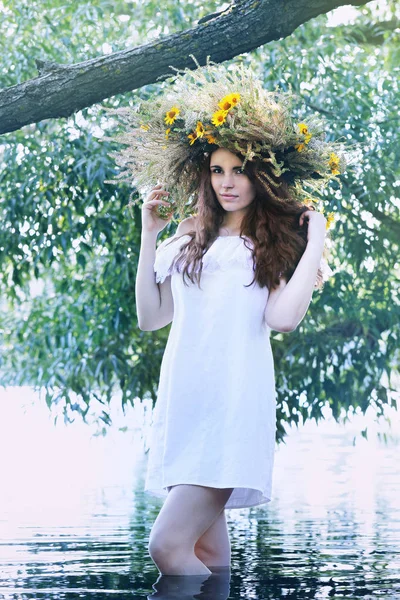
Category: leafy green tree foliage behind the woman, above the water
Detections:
[{"x1": 0, "y1": 0, "x2": 400, "y2": 441}]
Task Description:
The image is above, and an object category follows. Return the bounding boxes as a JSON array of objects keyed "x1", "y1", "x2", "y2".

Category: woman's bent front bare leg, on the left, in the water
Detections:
[{"x1": 149, "y1": 484, "x2": 233, "y2": 575}]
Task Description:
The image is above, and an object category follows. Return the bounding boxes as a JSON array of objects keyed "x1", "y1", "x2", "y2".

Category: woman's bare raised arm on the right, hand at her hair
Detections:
[{"x1": 265, "y1": 210, "x2": 326, "y2": 332}]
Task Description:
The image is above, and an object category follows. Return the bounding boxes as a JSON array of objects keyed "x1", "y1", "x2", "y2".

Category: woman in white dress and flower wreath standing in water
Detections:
[{"x1": 107, "y1": 57, "x2": 354, "y2": 575}]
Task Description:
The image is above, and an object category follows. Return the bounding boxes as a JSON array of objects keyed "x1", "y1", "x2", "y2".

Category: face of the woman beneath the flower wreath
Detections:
[{"x1": 210, "y1": 148, "x2": 256, "y2": 212}]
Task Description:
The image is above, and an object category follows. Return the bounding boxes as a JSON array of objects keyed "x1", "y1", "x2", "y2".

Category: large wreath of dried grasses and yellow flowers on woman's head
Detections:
[{"x1": 105, "y1": 55, "x2": 355, "y2": 227}]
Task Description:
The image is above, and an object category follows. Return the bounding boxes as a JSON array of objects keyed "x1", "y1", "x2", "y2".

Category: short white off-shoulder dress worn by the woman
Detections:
[{"x1": 145, "y1": 235, "x2": 276, "y2": 509}]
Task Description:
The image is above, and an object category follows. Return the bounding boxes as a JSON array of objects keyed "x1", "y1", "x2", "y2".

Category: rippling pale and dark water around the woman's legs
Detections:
[{"x1": 0, "y1": 388, "x2": 400, "y2": 600}]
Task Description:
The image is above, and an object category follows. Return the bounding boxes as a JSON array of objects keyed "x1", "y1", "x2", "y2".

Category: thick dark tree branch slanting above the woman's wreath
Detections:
[{"x1": 0, "y1": 0, "x2": 372, "y2": 133}]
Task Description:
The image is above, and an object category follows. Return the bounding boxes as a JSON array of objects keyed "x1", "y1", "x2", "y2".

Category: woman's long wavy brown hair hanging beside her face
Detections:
[{"x1": 167, "y1": 152, "x2": 323, "y2": 290}]
